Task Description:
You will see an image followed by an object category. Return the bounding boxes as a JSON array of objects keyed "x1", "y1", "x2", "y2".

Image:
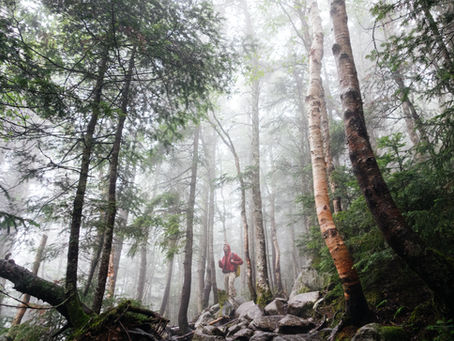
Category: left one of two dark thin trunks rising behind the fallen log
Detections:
[{"x1": 65, "y1": 46, "x2": 109, "y2": 296}]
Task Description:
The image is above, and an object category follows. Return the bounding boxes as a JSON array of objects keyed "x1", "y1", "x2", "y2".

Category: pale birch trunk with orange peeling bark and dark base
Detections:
[{"x1": 306, "y1": 1, "x2": 370, "y2": 324}]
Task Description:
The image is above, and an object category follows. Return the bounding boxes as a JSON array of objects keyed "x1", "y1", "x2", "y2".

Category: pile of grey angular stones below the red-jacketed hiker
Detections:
[{"x1": 193, "y1": 291, "x2": 329, "y2": 341}]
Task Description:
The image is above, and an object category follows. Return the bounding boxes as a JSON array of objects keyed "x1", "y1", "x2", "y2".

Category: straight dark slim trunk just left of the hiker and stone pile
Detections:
[{"x1": 178, "y1": 125, "x2": 200, "y2": 334}]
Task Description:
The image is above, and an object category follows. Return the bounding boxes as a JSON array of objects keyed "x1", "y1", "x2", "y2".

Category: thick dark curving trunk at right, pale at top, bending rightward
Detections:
[{"x1": 331, "y1": 0, "x2": 454, "y2": 316}]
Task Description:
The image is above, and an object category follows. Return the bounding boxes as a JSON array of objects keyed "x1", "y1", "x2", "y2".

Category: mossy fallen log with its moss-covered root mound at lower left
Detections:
[{"x1": 0, "y1": 259, "x2": 169, "y2": 341}]
